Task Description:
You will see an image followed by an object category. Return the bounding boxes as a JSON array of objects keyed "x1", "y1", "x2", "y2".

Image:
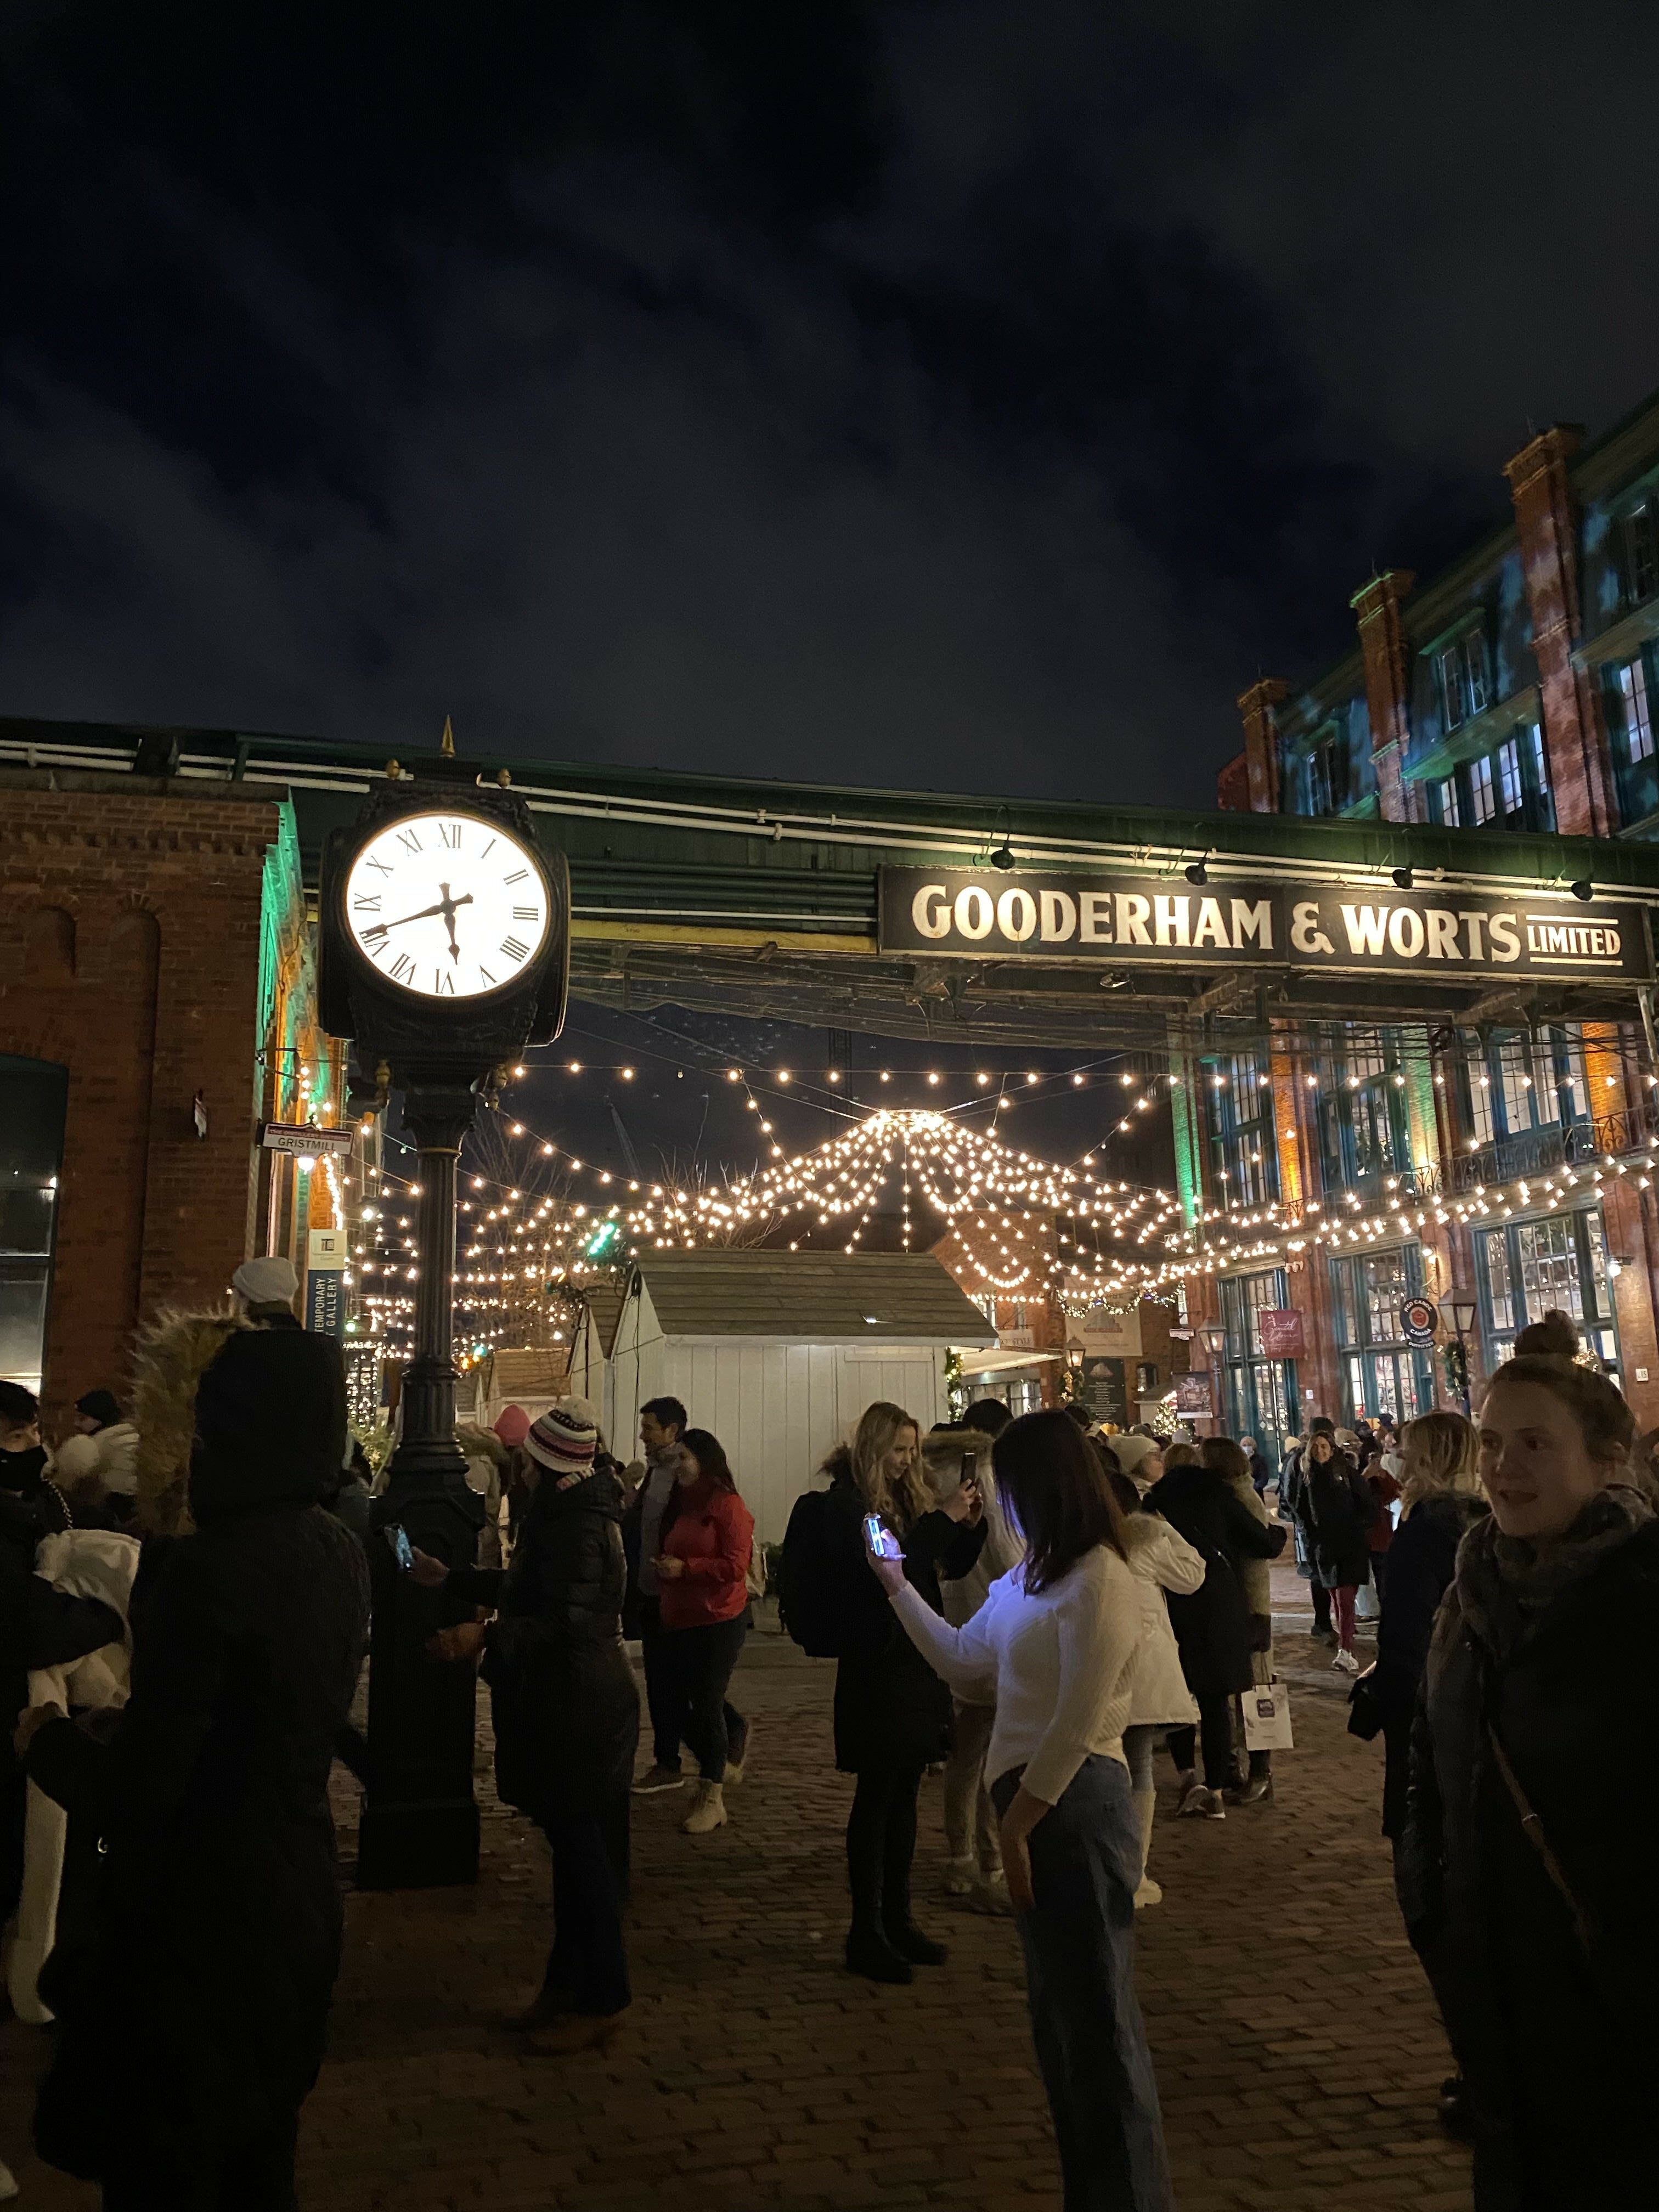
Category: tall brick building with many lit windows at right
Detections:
[{"x1": 1175, "y1": 396, "x2": 1659, "y2": 1434}]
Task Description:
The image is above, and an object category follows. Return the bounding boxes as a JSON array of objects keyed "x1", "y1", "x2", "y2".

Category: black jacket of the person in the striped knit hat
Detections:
[{"x1": 449, "y1": 1466, "x2": 639, "y2": 1874}]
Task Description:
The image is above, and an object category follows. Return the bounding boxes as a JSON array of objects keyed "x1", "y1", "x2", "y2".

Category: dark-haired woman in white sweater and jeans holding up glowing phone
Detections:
[{"x1": 870, "y1": 1411, "x2": 1175, "y2": 2212}]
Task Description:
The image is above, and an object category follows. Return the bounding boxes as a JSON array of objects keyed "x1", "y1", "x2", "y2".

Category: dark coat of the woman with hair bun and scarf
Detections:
[{"x1": 1398, "y1": 1509, "x2": 1659, "y2": 2212}]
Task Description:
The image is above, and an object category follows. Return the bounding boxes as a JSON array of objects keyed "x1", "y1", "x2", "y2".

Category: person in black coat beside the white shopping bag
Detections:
[{"x1": 1146, "y1": 1444, "x2": 1285, "y2": 1820}]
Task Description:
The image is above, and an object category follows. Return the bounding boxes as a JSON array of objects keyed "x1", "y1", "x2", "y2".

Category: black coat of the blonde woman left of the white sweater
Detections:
[{"x1": 825, "y1": 1451, "x2": 984, "y2": 1774}]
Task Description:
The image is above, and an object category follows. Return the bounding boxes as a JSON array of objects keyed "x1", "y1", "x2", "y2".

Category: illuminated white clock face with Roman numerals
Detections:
[{"x1": 345, "y1": 812, "x2": 553, "y2": 997}]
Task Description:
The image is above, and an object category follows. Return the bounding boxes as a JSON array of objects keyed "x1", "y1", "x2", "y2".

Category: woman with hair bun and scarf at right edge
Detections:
[{"x1": 1398, "y1": 1356, "x2": 1659, "y2": 2212}]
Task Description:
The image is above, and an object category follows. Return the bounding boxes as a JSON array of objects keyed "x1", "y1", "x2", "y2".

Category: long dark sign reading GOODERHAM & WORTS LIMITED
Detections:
[{"x1": 878, "y1": 867, "x2": 1652, "y2": 982}]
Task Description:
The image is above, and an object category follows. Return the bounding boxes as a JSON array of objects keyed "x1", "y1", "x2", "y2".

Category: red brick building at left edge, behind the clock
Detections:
[{"x1": 0, "y1": 768, "x2": 338, "y2": 1425}]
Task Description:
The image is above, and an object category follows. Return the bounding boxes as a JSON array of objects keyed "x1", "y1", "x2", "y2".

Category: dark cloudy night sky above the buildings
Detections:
[{"x1": 0, "y1": 0, "x2": 1659, "y2": 805}]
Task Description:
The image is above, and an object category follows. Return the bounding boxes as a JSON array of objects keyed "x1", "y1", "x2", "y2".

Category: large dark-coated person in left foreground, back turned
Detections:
[{"x1": 18, "y1": 1321, "x2": 369, "y2": 2212}]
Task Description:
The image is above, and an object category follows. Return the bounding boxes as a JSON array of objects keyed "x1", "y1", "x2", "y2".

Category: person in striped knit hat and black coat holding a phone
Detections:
[{"x1": 414, "y1": 1398, "x2": 639, "y2": 2053}]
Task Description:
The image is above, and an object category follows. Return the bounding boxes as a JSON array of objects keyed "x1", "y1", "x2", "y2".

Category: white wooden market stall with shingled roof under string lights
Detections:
[{"x1": 571, "y1": 1248, "x2": 995, "y2": 1544}]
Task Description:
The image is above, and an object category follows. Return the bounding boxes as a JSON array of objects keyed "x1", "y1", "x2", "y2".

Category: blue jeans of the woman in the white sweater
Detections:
[{"x1": 991, "y1": 1756, "x2": 1175, "y2": 2212}]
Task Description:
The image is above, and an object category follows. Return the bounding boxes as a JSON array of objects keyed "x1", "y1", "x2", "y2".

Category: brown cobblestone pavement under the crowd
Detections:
[{"x1": 0, "y1": 1577, "x2": 1469, "y2": 2212}]
